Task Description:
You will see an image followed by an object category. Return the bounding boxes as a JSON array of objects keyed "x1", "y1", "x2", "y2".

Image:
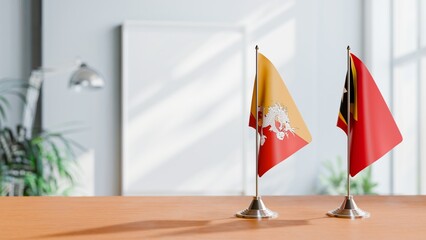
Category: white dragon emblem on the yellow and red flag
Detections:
[{"x1": 258, "y1": 103, "x2": 296, "y2": 145}]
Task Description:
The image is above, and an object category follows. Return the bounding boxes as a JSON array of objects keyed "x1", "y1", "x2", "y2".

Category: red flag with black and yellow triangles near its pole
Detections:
[{"x1": 337, "y1": 53, "x2": 402, "y2": 176}]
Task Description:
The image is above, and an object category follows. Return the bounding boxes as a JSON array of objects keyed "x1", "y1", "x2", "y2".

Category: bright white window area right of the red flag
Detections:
[{"x1": 365, "y1": 0, "x2": 426, "y2": 195}]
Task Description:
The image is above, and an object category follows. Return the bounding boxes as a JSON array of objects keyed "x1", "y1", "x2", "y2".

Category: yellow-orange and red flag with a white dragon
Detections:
[{"x1": 249, "y1": 53, "x2": 312, "y2": 177}]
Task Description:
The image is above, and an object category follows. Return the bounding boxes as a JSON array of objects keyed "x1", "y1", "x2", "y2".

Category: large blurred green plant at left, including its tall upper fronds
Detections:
[{"x1": 0, "y1": 80, "x2": 82, "y2": 196}]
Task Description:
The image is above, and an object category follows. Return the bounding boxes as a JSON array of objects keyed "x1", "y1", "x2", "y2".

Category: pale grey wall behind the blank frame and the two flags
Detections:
[{"x1": 42, "y1": 0, "x2": 363, "y2": 195}]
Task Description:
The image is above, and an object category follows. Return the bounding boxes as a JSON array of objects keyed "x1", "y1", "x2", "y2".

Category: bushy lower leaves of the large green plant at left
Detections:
[{"x1": 0, "y1": 122, "x2": 82, "y2": 196}]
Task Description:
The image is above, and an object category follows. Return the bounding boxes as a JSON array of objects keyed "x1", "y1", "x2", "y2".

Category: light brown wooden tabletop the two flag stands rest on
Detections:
[{"x1": 0, "y1": 196, "x2": 426, "y2": 240}]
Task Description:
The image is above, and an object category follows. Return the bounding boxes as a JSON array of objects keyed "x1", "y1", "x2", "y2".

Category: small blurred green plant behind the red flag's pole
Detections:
[{"x1": 319, "y1": 157, "x2": 378, "y2": 195}]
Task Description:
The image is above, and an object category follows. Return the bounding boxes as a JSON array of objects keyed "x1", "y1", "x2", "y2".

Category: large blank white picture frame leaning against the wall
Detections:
[{"x1": 121, "y1": 21, "x2": 250, "y2": 195}]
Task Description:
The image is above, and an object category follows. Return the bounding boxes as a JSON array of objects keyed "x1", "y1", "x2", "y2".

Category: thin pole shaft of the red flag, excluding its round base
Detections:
[{"x1": 346, "y1": 45, "x2": 351, "y2": 197}]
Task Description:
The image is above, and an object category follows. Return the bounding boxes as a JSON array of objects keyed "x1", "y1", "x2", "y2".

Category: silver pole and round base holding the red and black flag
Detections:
[{"x1": 327, "y1": 46, "x2": 370, "y2": 219}]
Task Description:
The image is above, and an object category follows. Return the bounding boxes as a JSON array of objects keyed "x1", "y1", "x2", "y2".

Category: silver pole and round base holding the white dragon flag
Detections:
[{"x1": 235, "y1": 45, "x2": 278, "y2": 218}]
